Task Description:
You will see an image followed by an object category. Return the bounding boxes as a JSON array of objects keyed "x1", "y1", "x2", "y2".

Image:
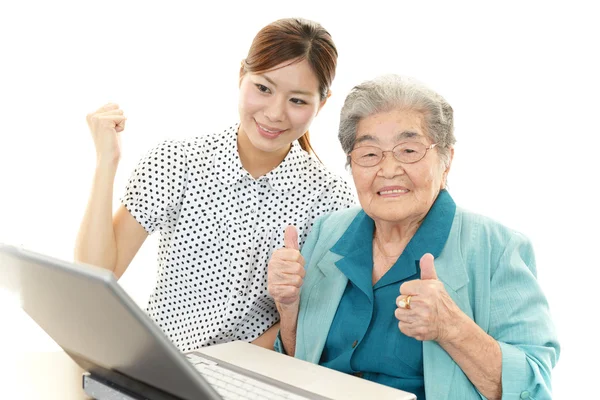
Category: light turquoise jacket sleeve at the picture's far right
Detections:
[{"x1": 489, "y1": 234, "x2": 560, "y2": 399}]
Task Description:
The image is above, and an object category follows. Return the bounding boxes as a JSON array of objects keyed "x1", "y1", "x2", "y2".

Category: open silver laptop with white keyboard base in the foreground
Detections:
[{"x1": 0, "y1": 243, "x2": 416, "y2": 400}]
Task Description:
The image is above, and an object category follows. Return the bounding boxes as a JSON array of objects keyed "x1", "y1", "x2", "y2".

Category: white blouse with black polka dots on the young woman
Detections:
[{"x1": 121, "y1": 124, "x2": 355, "y2": 351}]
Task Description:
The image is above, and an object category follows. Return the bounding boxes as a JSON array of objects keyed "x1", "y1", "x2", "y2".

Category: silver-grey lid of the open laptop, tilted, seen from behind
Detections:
[{"x1": 0, "y1": 243, "x2": 221, "y2": 400}]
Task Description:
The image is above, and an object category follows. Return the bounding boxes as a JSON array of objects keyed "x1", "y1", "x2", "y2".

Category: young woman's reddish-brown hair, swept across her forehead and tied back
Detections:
[{"x1": 240, "y1": 18, "x2": 338, "y2": 153}]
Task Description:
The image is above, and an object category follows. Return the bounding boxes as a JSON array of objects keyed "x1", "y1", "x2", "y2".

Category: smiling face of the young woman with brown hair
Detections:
[{"x1": 239, "y1": 60, "x2": 325, "y2": 153}]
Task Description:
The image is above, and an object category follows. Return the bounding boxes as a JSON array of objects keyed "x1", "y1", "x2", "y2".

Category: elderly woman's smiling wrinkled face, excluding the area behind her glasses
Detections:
[{"x1": 352, "y1": 110, "x2": 452, "y2": 222}]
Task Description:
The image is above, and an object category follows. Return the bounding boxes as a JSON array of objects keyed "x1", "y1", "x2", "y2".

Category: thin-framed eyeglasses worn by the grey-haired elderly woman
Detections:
[{"x1": 348, "y1": 142, "x2": 437, "y2": 167}]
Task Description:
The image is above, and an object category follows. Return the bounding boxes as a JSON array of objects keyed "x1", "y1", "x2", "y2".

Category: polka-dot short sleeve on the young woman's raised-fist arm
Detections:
[{"x1": 121, "y1": 140, "x2": 188, "y2": 234}]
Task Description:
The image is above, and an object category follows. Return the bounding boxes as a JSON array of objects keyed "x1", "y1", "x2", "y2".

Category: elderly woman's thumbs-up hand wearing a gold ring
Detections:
[{"x1": 395, "y1": 253, "x2": 464, "y2": 342}]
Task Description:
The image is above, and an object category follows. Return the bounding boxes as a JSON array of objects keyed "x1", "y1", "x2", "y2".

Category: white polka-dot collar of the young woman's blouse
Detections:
[{"x1": 214, "y1": 123, "x2": 307, "y2": 192}]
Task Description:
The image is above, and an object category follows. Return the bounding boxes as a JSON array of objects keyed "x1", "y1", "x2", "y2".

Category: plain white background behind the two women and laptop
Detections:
[{"x1": 0, "y1": 0, "x2": 600, "y2": 399}]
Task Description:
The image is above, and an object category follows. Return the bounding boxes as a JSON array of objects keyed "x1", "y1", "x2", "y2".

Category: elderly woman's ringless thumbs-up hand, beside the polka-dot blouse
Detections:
[{"x1": 267, "y1": 225, "x2": 305, "y2": 314}]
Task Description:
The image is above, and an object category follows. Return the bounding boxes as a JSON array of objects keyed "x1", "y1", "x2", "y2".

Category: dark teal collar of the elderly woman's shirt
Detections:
[{"x1": 330, "y1": 190, "x2": 456, "y2": 299}]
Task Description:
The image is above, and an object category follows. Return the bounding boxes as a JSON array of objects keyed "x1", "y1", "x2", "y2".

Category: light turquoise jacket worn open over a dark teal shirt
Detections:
[{"x1": 275, "y1": 207, "x2": 560, "y2": 400}]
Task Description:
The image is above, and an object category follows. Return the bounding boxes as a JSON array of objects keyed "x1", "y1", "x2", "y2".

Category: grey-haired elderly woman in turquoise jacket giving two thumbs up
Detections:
[{"x1": 268, "y1": 75, "x2": 559, "y2": 400}]
